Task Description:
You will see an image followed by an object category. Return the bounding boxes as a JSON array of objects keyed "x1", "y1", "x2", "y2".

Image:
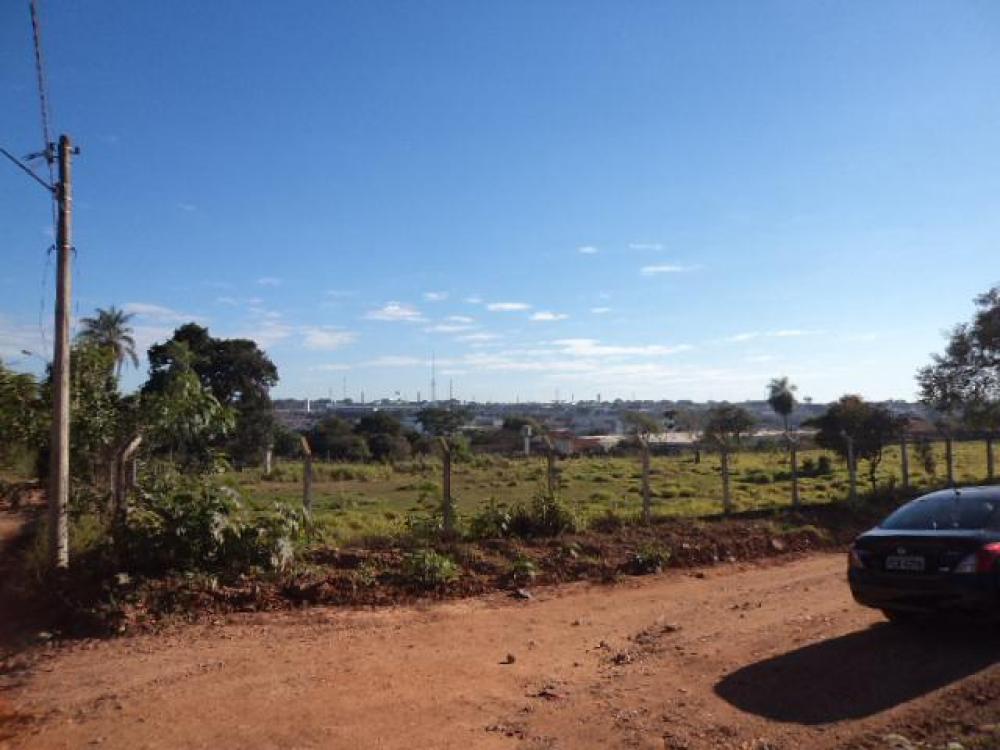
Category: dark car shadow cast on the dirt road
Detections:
[{"x1": 715, "y1": 622, "x2": 1000, "y2": 724}]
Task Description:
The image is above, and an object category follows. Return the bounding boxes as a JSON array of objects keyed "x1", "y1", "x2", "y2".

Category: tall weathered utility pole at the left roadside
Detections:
[{"x1": 48, "y1": 135, "x2": 78, "y2": 568}]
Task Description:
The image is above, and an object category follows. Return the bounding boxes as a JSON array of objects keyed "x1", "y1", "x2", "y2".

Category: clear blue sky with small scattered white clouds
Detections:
[{"x1": 0, "y1": 0, "x2": 1000, "y2": 400}]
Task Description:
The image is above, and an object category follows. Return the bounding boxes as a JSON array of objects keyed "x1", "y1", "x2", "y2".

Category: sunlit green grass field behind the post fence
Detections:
[{"x1": 228, "y1": 442, "x2": 986, "y2": 542}]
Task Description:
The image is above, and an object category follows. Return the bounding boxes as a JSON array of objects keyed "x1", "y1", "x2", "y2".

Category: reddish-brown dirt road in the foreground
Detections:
[{"x1": 0, "y1": 555, "x2": 1000, "y2": 750}]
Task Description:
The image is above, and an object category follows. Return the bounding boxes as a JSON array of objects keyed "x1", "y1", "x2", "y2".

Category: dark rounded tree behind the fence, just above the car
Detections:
[{"x1": 807, "y1": 394, "x2": 904, "y2": 499}]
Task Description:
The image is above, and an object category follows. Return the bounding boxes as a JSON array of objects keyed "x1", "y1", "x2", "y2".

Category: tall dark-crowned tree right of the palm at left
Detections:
[{"x1": 143, "y1": 323, "x2": 278, "y2": 462}]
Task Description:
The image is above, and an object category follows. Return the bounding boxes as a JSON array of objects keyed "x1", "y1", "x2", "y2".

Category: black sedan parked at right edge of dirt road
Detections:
[{"x1": 848, "y1": 487, "x2": 1000, "y2": 622}]
